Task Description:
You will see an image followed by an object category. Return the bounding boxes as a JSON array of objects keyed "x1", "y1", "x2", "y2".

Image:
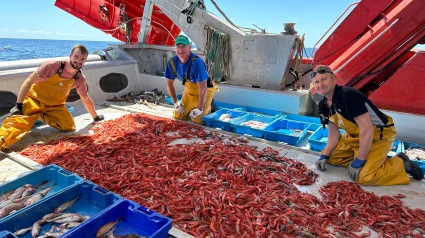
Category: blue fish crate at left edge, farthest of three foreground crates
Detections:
[{"x1": 0, "y1": 164, "x2": 83, "y2": 222}]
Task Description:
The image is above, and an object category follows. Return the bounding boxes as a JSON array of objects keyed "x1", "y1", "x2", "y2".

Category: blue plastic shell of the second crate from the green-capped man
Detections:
[{"x1": 230, "y1": 113, "x2": 277, "y2": 138}]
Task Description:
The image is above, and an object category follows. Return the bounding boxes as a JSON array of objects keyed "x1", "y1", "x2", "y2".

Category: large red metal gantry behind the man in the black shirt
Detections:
[{"x1": 314, "y1": 0, "x2": 425, "y2": 115}]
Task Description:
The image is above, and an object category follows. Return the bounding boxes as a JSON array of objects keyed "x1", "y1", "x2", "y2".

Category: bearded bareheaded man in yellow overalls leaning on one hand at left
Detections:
[{"x1": 0, "y1": 44, "x2": 104, "y2": 151}]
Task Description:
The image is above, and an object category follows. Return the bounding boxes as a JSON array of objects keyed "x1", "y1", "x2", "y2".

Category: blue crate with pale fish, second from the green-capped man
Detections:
[{"x1": 230, "y1": 113, "x2": 277, "y2": 138}]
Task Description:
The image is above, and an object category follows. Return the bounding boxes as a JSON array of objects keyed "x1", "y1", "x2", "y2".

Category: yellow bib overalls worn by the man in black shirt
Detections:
[{"x1": 322, "y1": 113, "x2": 410, "y2": 185}]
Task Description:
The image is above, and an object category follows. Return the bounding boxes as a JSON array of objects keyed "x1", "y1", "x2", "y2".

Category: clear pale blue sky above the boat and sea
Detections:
[{"x1": 0, "y1": 0, "x2": 420, "y2": 48}]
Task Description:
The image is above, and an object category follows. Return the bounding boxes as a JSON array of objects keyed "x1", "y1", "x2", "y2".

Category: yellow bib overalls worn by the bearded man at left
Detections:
[{"x1": 0, "y1": 74, "x2": 75, "y2": 151}]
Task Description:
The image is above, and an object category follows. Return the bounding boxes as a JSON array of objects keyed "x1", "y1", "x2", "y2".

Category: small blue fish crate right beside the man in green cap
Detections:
[{"x1": 202, "y1": 109, "x2": 248, "y2": 131}]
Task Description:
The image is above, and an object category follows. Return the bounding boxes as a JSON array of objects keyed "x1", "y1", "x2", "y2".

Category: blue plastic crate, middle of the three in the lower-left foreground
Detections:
[{"x1": 0, "y1": 181, "x2": 122, "y2": 238}]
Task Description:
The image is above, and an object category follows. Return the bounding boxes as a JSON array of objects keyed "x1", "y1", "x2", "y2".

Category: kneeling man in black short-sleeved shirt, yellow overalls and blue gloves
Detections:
[{"x1": 311, "y1": 65, "x2": 424, "y2": 185}]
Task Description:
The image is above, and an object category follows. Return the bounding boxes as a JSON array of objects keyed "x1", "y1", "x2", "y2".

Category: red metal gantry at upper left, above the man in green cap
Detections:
[{"x1": 55, "y1": 0, "x2": 180, "y2": 46}]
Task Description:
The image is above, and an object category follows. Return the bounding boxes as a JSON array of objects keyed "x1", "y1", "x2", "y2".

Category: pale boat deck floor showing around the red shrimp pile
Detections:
[{"x1": 0, "y1": 102, "x2": 425, "y2": 237}]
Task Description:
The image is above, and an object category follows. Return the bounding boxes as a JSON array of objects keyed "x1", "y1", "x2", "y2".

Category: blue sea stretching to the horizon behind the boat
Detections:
[{"x1": 0, "y1": 38, "x2": 312, "y2": 62}]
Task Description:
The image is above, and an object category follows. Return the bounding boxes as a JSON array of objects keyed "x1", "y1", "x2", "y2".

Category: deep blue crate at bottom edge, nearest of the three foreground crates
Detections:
[{"x1": 63, "y1": 200, "x2": 172, "y2": 238}]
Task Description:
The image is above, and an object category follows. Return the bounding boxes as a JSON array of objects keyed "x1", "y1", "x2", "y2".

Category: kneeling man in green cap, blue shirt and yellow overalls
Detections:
[{"x1": 164, "y1": 35, "x2": 216, "y2": 124}]
